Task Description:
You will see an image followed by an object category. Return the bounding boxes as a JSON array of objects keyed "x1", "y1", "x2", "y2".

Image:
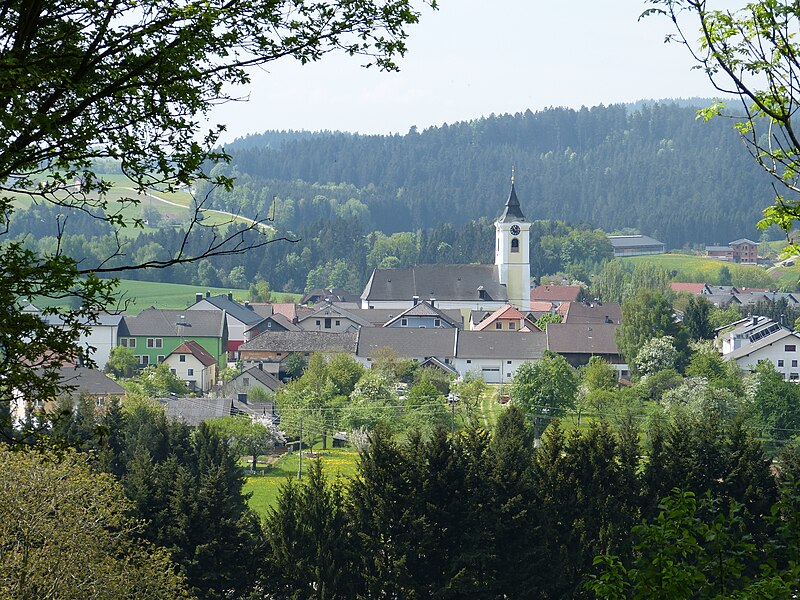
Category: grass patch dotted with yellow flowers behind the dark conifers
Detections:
[{"x1": 243, "y1": 448, "x2": 358, "y2": 517}]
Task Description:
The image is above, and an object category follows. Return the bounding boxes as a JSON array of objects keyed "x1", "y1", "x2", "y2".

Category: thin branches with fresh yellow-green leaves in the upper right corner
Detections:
[{"x1": 645, "y1": 0, "x2": 800, "y2": 254}]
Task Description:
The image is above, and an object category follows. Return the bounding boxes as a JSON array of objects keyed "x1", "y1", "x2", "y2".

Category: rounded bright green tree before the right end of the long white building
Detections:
[{"x1": 511, "y1": 351, "x2": 578, "y2": 419}]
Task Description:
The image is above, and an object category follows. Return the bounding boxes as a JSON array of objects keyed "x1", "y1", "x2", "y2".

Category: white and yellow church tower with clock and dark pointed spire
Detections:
[{"x1": 494, "y1": 171, "x2": 531, "y2": 312}]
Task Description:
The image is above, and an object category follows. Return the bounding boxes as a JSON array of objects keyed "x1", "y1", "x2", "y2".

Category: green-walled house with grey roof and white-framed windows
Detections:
[{"x1": 117, "y1": 307, "x2": 228, "y2": 369}]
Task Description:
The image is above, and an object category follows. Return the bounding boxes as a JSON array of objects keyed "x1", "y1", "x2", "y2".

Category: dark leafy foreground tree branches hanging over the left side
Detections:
[{"x1": 0, "y1": 0, "x2": 435, "y2": 432}]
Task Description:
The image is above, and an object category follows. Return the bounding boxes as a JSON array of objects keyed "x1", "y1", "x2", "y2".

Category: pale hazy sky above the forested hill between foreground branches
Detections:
[{"x1": 209, "y1": 0, "x2": 714, "y2": 142}]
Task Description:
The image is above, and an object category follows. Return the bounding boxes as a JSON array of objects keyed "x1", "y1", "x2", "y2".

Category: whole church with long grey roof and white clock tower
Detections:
[{"x1": 361, "y1": 175, "x2": 531, "y2": 313}]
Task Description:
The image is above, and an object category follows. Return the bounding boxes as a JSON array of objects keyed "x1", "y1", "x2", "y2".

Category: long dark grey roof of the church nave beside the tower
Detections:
[{"x1": 361, "y1": 265, "x2": 508, "y2": 303}]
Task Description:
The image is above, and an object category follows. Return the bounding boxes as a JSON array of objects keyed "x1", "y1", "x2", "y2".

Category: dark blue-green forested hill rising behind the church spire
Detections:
[{"x1": 215, "y1": 103, "x2": 772, "y2": 247}]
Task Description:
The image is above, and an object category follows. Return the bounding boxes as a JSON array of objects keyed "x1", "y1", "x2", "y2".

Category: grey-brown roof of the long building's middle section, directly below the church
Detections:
[{"x1": 356, "y1": 327, "x2": 459, "y2": 358}]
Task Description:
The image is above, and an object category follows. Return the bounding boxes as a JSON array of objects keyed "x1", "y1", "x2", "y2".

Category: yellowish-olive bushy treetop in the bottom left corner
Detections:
[{"x1": 0, "y1": 446, "x2": 189, "y2": 600}]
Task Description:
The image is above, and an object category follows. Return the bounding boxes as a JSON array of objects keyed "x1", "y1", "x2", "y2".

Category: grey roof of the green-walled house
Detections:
[{"x1": 119, "y1": 308, "x2": 226, "y2": 338}]
